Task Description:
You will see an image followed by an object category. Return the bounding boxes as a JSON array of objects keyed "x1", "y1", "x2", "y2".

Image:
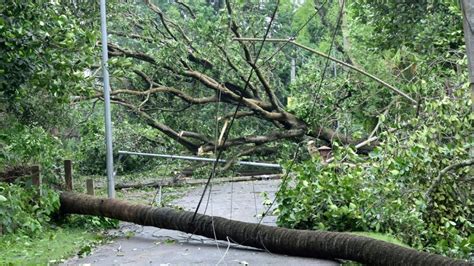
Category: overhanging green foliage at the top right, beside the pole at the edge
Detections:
[{"x1": 351, "y1": 0, "x2": 463, "y2": 54}]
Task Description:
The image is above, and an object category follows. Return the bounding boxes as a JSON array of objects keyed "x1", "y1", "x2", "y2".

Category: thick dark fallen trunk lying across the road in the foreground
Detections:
[{"x1": 60, "y1": 192, "x2": 469, "y2": 265}]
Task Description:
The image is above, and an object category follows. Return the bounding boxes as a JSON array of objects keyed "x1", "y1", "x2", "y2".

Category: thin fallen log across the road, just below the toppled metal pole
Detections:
[{"x1": 115, "y1": 174, "x2": 281, "y2": 189}]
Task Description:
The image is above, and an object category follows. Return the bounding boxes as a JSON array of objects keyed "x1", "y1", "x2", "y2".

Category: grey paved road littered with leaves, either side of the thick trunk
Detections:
[{"x1": 65, "y1": 180, "x2": 337, "y2": 266}]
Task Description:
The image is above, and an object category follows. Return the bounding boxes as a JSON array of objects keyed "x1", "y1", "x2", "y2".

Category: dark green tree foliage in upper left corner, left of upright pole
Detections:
[{"x1": 0, "y1": 1, "x2": 95, "y2": 125}]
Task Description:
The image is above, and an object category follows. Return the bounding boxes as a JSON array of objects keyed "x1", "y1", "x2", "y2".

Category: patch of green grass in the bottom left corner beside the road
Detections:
[{"x1": 0, "y1": 227, "x2": 104, "y2": 265}]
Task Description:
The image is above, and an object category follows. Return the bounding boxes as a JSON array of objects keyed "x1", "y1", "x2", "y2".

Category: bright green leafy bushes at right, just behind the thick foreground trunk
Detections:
[{"x1": 278, "y1": 88, "x2": 474, "y2": 258}]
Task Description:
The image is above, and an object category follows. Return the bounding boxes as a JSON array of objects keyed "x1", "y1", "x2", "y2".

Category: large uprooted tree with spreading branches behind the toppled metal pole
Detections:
[{"x1": 76, "y1": 1, "x2": 406, "y2": 158}]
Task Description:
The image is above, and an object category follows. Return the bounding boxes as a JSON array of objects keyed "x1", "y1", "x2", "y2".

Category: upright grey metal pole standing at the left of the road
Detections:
[{"x1": 100, "y1": 0, "x2": 115, "y2": 198}]
